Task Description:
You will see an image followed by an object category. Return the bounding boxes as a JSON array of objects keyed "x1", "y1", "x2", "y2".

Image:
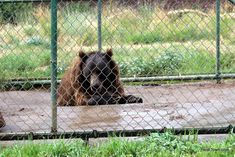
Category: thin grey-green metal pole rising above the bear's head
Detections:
[{"x1": 98, "y1": 0, "x2": 102, "y2": 51}]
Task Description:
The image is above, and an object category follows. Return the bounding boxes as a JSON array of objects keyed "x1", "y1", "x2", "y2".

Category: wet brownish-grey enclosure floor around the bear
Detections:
[{"x1": 0, "y1": 82, "x2": 235, "y2": 134}]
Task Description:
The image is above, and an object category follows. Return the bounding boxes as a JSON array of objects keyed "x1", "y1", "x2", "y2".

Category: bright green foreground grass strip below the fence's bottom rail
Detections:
[{"x1": 0, "y1": 132, "x2": 235, "y2": 157}]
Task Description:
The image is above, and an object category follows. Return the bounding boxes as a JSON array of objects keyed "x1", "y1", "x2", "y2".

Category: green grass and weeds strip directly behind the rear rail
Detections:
[{"x1": 0, "y1": 41, "x2": 235, "y2": 80}]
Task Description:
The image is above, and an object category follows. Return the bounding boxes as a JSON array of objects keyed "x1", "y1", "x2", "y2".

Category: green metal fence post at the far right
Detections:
[{"x1": 215, "y1": 0, "x2": 221, "y2": 83}]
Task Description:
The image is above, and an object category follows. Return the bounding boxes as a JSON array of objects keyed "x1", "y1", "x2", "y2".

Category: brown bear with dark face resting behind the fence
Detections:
[{"x1": 57, "y1": 49, "x2": 143, "y2": 106}]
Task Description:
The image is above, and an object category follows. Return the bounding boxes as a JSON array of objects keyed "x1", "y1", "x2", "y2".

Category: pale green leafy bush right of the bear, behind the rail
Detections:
[{"x1": 119, "y1": 50, "x2": 183, "y2": 76}]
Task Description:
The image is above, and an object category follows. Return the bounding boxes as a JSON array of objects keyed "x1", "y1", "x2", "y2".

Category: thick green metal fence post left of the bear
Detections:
[{"x1": 51, "y1": 0, "x2": 57, "y2": 133}]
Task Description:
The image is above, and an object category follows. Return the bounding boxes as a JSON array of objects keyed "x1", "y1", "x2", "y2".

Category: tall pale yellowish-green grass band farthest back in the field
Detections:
[{"x1": 3, "y1": 3, "x2": 235, "y2": 46}]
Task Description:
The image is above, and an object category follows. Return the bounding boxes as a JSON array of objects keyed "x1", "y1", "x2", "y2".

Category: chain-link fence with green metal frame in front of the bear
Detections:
[{"x1": 0, "y1": 0, "x2": 235, "y2": 140}]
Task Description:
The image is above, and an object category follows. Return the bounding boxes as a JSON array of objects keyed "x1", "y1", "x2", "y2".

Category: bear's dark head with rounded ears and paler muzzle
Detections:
[{"x1": 79, "y1": 49, "x2": 118, "y2": 96}]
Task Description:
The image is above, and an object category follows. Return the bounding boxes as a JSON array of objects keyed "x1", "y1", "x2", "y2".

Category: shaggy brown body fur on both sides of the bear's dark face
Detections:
[{"x1": 57, "y1": 49, "x2": 124, "y2": 106}]
